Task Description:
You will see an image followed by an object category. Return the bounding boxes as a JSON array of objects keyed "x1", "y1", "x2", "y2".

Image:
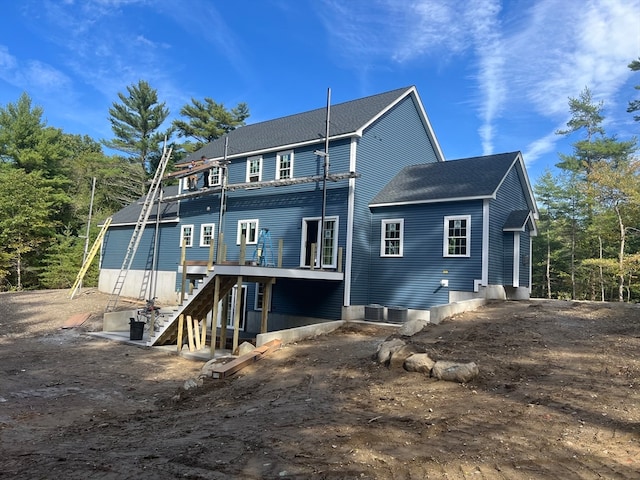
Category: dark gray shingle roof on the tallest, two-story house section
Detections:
[{"x1": 184, "y1": 87, "x2": 412, "y2": 162}]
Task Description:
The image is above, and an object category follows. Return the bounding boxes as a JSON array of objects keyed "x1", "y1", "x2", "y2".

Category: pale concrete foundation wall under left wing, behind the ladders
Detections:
[{"x1": 98, "y1": 269, "x2": 178, "y2": 305}]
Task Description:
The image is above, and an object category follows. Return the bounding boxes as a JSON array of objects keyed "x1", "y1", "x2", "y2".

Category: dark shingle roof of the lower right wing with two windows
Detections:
[{"x1": 369, "y1": 152, "x2": 520, "y2": 206}]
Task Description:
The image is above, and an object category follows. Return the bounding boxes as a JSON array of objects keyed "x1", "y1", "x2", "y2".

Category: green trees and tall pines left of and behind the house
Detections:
[{"x1": 0, "y1": 80, "x2": 249, "y2": 291}]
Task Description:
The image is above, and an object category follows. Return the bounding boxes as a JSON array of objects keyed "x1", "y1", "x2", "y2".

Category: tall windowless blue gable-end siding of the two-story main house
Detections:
[{"x1": 350, "y1": 92, "x2": 437, "y2": 305}]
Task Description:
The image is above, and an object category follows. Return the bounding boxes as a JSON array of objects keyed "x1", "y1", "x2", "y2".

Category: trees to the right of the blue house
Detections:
[{"x1": 532, "y1": 59, "x2": 640, "y2": 302}]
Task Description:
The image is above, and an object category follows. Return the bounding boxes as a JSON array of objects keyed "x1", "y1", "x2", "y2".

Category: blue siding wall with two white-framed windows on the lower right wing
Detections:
[{"x1": 365, "y1": 201, "x2": 482, "y2": 309}]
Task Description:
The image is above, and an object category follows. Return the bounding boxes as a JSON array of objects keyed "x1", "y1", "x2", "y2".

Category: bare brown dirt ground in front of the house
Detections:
[{"x1": 0, "y1": 290, "x2": 640, "y2": 480}]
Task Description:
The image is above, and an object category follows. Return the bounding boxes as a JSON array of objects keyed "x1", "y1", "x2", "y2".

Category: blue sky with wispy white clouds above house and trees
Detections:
[{"x1": 0, "y1": 0, "x2": 640, "y2": 182}]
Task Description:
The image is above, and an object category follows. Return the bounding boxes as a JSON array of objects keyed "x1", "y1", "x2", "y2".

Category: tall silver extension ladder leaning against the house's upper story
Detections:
[{"x1": 105, "y1": 144, "x2": 173, "y2": 312}]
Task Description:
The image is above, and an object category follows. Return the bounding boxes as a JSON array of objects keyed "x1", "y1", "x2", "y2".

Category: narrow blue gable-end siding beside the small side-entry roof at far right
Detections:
[{"x1": 489, "y1": 167, "x2": 529, "y2": 285}]
